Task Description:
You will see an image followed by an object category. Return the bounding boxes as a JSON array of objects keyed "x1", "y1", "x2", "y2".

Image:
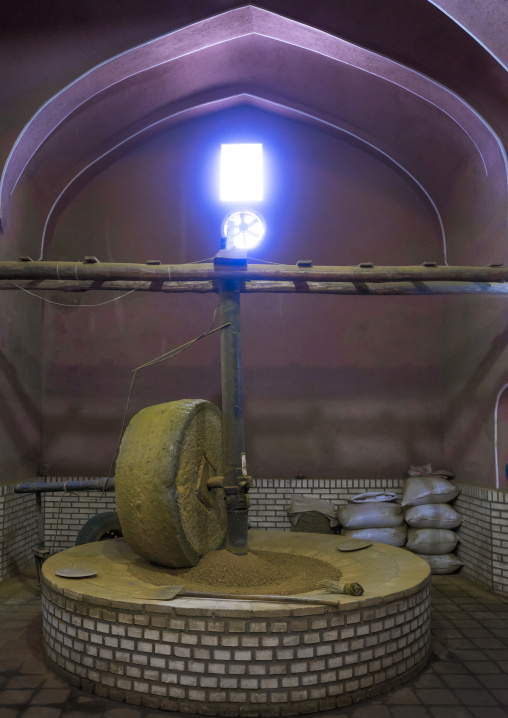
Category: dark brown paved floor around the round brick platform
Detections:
[{"x1": 0, "y1": 572, "x2": 508, "y2": 718}]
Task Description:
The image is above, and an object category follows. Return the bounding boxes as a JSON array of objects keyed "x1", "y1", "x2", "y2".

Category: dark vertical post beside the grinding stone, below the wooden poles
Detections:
[{"x1": 219, "y1": 280, "x2": 248, "y2": 555}]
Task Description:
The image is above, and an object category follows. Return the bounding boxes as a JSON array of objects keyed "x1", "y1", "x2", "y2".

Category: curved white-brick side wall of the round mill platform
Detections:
[{"x1": 43, "y1": 579, "x2": 430, "y2": 718}]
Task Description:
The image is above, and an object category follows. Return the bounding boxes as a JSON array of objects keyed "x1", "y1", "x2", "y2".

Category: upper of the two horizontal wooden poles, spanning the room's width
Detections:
[{"x1": 0, "y1": 261, "x2": 508, "y2": 283}]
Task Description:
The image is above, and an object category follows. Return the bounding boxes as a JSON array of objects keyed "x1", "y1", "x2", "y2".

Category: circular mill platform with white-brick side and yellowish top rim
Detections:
[{"x1": 42, "y1": 531, "x2": 430, "y2": 718}]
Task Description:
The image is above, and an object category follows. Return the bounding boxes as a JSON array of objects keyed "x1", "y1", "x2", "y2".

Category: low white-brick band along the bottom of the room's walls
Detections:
[{"x1": 0, "y1": 478, "x2": 508, "y2": 595}]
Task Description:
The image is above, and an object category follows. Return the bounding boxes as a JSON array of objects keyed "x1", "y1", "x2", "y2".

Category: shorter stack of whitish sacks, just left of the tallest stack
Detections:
[{"x1": 337, "y1": 491, "x2": 407, "y2": 547}]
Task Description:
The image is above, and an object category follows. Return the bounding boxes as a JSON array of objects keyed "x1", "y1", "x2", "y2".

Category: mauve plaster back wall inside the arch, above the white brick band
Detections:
[{"x1": 43, "y1": 109, "x2": 443, "y2": 478}]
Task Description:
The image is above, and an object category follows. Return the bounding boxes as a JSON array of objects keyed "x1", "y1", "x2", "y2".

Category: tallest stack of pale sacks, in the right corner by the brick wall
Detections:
[{"x1": 402, "y1": 464, "x2": 463, "y2": 574}]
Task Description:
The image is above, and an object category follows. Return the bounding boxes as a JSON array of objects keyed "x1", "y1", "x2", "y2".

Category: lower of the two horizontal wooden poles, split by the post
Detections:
[{"x1": 0, "y1": 279, "x2": 508, "y2": 296}]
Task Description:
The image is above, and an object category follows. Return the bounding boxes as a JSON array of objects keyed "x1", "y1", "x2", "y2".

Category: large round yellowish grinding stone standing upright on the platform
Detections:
[{"x1": 115, "y1": 399, "x2": 226, "y2": 568}]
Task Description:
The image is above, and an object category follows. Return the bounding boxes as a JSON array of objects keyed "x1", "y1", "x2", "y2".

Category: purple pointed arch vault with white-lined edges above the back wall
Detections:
[{"x1": 0, "y1": 6, "x2": 507, "y2": 260}]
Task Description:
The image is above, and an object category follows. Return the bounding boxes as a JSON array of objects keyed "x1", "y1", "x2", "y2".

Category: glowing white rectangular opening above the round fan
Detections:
[{"x1": 220, "y1": 144, "x2": 263, "y2": 202}]
